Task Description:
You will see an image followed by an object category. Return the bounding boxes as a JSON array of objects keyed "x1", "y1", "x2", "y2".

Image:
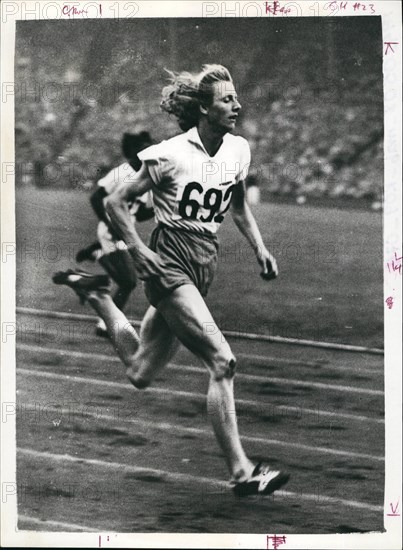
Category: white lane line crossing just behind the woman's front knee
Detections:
[{"x1": 17, "y1": 344, "x2": 384, "y2": 397}]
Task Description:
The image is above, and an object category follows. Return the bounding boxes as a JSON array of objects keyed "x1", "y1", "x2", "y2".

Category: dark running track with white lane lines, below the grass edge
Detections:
[{"x1": 17, "y1": 309, "x2": 384, "y2": 534}]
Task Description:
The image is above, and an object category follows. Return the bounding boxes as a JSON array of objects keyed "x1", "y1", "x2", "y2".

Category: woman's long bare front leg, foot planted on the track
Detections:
[{"x1": 158, "y1": 284, "x2": 254, "y2": 480}]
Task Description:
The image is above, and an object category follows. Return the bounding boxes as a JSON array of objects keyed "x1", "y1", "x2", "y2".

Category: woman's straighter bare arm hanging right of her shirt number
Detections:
[{"x1": 231, "y1": 181, "x2": 278, "y2": 278}]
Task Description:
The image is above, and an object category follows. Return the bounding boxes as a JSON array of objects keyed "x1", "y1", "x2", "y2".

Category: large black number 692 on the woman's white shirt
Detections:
[{"x1": 178, "y1": 181, "x2": 235, "y2": 223}]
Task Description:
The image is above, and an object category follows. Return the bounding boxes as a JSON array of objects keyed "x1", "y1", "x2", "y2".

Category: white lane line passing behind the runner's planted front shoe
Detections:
[{"x1": 17, "y1": 448, "x2": 383, "y2": 516}]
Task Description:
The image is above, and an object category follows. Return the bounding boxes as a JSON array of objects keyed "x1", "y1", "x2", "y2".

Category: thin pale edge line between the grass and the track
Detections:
[{"x1": 17, "y1": 307, "x2": 384, "y2": 355}]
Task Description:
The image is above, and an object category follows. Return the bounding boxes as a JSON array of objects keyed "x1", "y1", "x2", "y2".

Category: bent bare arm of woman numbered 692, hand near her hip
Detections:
[{"x1": 105, "y1": 163, "x2": 166, "y2": 279}]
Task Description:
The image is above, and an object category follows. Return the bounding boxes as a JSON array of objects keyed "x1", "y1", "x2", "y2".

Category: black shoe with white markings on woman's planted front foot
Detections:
[{"x1": 233, "y1": 462, "x2": 290, "y2": 497}]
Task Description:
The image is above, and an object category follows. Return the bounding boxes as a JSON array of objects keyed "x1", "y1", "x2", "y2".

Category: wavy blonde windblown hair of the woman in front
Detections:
[{"x1": 160, "y1": 65, "x2": 232, "y2": 132}]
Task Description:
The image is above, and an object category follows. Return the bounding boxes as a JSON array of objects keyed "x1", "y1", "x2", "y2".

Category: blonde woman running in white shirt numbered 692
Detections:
[{"x1": 54, "y1": 65, "x2": 289, "y2": 496}]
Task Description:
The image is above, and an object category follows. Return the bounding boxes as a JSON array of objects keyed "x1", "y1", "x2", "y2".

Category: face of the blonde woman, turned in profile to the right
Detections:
[{"x1": 206, "y1": 81, "x2": 241, "y2": 132}]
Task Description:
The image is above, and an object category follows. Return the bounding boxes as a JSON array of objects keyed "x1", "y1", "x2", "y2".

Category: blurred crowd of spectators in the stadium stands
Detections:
[{"x1": 15, "y1": 18, "x2": 383, "y2": 205}]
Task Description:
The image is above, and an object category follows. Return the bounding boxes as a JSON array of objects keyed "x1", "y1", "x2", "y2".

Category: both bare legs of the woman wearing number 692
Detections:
[{"x1": 89, "y1": 284, "x2": 254, "y2": 481}]
